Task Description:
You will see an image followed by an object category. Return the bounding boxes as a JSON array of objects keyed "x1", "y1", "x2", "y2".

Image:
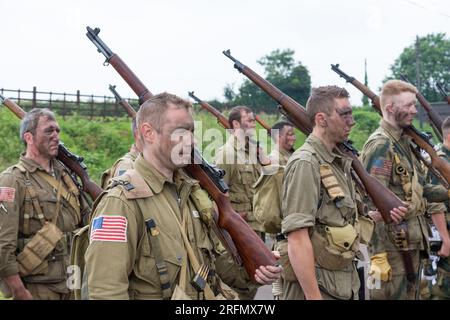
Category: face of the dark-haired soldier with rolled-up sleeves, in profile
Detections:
[{"x1": 327, "y1": 98, "x2": 355, "y2": 143}]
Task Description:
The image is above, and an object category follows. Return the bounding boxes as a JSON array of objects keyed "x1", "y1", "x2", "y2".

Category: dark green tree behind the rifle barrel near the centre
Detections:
[{"x1": 224, "y1": 49, "x2": 311, "y2": 113}]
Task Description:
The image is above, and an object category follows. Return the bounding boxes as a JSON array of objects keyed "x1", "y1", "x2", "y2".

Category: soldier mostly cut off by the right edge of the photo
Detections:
[{"x1": 431, "y1": 117, "x2": 450, "y2": 300}]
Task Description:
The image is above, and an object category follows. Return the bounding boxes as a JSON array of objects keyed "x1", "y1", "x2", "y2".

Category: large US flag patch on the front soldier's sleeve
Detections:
[{"x1": 90, "y1": 216, "x2": 128, "y2": 242}]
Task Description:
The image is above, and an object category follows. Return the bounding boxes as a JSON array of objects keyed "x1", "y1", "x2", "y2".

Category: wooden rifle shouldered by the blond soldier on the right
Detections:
[{"x1": 331, "y1": 64, "x2": 450, "y2": 189}]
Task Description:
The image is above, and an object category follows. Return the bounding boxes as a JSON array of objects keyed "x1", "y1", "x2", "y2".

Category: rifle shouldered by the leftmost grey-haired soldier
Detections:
[{"x1": 0, "y1": 95, "x2": 103, "y2": 200}]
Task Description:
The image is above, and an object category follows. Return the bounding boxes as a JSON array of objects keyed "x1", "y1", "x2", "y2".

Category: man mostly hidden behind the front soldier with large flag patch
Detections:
[{"x1": 100, "y1": 118, "x2": 142, "y2": 189}]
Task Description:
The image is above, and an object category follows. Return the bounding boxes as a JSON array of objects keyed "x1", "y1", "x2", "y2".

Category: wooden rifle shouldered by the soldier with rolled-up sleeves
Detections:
[{"x1": 223, "y1": 50, "x2": 415, "y2": 283}]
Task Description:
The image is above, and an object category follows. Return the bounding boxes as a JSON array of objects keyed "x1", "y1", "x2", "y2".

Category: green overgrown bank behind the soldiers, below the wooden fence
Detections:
[{"x1": 0, "y1": 108, "x2": 390, "y2": 182}]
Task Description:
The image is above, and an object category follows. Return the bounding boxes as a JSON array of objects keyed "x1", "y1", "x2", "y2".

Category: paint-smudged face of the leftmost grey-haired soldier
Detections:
[{"x1": 27, "y1": 117, "x2": 60, "y2": 159}]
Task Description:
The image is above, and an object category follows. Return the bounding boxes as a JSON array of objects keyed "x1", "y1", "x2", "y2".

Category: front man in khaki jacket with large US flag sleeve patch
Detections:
[{"x1": 85, "y1": 93, "x2": 281, "y2": 299}]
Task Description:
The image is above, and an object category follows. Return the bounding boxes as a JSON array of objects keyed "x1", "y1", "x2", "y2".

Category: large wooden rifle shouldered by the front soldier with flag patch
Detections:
[{"x1": 88, "y1": 27, "x2": 278, "y2": 280}]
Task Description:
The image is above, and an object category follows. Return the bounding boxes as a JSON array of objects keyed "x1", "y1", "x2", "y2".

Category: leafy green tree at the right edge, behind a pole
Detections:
[{"x1": 385, "y1": 33, "x2": 450, "y2": 102}]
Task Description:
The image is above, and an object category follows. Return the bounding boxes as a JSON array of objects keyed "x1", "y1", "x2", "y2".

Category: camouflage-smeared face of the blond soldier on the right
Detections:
[{"x1": 387, "y1": 92, "x2": 417, "y2": 129}]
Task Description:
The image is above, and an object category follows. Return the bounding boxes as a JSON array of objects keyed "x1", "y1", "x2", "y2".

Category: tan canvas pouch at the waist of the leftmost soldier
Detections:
[{"x1": 17, "y1": 221, "x2": 62, "y2": 277}]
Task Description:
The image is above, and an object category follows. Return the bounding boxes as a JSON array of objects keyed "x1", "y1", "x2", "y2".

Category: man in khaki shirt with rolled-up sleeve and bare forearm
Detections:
[{"x1": 280, "y1": 86, "x2": 406, "y2": 300}]
